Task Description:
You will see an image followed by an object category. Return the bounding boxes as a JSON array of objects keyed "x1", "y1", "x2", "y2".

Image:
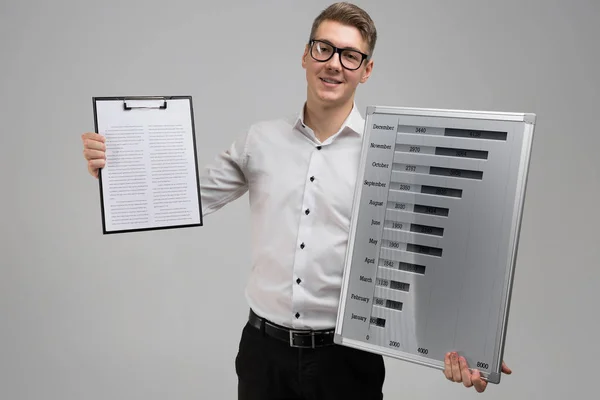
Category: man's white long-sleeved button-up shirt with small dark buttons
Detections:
[{"x1": 200, "y1": 105, "x2": 364, "y2": 329}]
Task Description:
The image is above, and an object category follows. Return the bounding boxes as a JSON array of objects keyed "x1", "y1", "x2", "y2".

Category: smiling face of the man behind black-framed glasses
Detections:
[{"x1": 302, "y1": 21, "x2": 373, "y2": 108}]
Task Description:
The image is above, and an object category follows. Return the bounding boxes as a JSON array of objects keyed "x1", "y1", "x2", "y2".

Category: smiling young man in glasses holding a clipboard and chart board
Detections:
[{"x1": 82, "y1": 3, "x2": 510, "y2": 400}]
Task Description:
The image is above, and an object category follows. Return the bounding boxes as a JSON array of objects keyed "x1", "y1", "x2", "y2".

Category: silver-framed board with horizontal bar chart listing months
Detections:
[{"x1": 335, "y1": 106, "x2": 536, "y2": 383}]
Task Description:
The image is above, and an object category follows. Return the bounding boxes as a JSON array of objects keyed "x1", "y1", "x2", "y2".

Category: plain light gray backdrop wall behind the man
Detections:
[{"x1": 0, "y1": 0, "x2": 600, "y2": 400}]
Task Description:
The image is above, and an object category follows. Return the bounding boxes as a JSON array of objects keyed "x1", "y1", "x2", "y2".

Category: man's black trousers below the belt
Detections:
[{"x1": 235, "y1": 324, "x2": 385, "y2": 400}]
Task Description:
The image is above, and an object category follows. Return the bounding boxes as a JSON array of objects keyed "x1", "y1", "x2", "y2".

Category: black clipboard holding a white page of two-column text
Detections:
[{"x1": 92, "y1": 96, "x2": 203, "y2": 234}]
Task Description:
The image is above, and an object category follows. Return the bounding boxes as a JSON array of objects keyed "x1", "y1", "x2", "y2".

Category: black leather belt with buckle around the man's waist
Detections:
[{"x1": 248, "y1": 310, "x2": 335, "y2": 349}]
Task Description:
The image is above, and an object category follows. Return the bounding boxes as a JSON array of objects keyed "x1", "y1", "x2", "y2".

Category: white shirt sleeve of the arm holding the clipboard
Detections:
[{"x1": 200, "y1": 133, "x2": 248, "y2": 216}]
